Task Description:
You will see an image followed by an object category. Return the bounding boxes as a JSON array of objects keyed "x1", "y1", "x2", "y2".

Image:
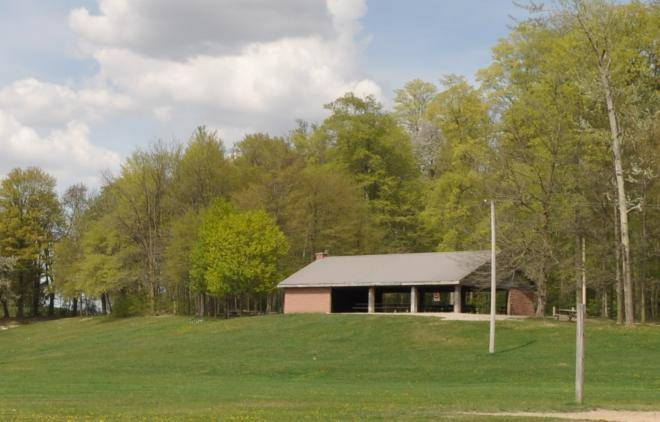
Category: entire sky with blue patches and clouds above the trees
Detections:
[{"x1": 0, "y1": 0, "x2": 525, "y2": 189}]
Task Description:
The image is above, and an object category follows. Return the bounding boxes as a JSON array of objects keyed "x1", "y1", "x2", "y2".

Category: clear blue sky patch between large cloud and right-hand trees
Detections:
[{"x1": 364, "y1": 0, "x2": 525, "y2": 91}]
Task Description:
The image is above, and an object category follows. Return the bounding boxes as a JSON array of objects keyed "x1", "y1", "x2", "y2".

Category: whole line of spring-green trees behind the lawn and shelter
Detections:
[{"x1": 0, "y1": 0, "x2": 660, "y2": 324}]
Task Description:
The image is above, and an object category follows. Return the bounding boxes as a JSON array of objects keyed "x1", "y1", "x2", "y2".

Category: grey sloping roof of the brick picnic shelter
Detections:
[{"x1": 279, "y1": 251, "x2": 490, "y2": 287}]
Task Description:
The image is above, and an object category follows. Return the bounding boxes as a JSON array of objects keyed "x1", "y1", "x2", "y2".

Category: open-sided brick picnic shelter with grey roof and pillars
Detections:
[{"x1": 279, "y1": 251, "x2": 534, "y2": 315}]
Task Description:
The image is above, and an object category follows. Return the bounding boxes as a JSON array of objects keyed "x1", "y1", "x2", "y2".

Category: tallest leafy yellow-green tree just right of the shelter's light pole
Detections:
[{"x1": 481, "y1": 16, "x2": 581, "y2": 316}]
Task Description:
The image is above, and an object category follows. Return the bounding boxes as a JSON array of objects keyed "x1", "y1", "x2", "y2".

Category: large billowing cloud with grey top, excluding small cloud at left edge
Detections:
[{"x1": 70, "y1": 0, "x2": 381, "y2": 130}]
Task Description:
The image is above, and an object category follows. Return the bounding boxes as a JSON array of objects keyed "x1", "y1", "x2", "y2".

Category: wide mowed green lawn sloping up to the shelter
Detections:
[{"x1": 0, "y1": 315, "x2": 660, "y2": 420}]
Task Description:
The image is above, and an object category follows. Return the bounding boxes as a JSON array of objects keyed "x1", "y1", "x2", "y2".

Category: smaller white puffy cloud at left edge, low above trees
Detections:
[{"x1": 0, "y1": 110, "x2": 120, "y2": 186}]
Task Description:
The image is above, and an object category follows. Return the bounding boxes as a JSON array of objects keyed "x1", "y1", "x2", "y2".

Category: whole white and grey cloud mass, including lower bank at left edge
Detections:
[{"x1": 0, "y1": 0, "x2": 381, "y2": 188}]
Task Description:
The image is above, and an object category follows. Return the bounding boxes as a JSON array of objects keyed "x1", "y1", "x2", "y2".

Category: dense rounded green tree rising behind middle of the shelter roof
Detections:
[{"x1": 318, "y1": 94, "x2": 423, "y2": 252}]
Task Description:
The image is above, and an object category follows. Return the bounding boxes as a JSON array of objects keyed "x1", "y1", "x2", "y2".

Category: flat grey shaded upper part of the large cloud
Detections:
[{"x1": 69, "y1": 0, "x2": 334, "y2": 58}]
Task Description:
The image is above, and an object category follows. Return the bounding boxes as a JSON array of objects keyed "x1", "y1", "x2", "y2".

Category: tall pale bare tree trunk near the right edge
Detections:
[{"x1": 599, "y1": 63, "x2": 635, "y2": 326}]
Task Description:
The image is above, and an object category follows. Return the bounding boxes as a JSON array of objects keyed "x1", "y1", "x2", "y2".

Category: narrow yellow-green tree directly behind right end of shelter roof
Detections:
[{"x1": 422, "y1": 76, "x2": 493, "y2": 250}]
